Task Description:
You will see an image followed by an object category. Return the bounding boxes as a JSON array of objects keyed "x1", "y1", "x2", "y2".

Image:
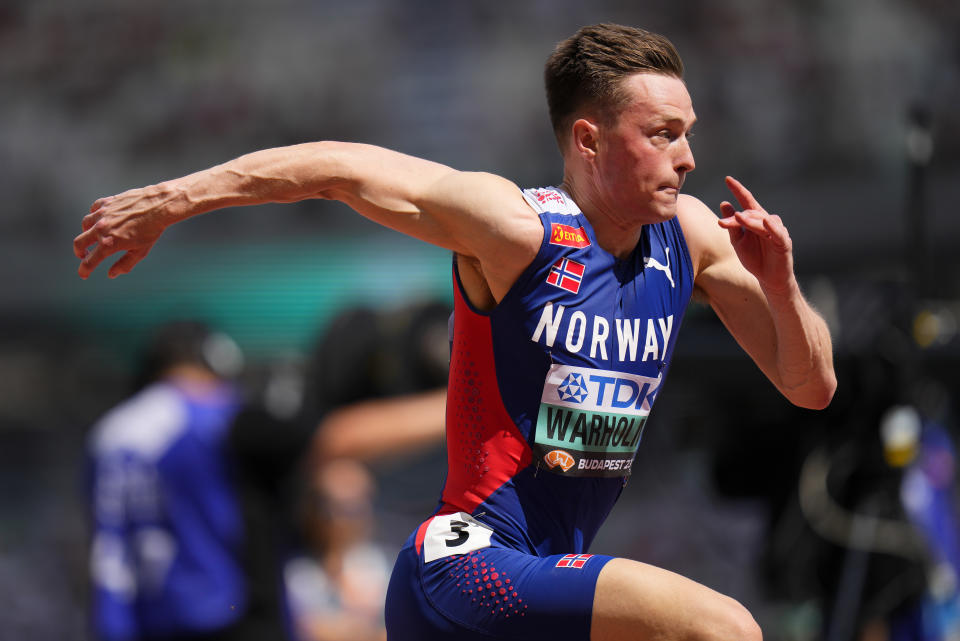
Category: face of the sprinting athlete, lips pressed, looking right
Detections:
[{"x1": 596, "y1": 73, "x2": 696, "y2": 226}]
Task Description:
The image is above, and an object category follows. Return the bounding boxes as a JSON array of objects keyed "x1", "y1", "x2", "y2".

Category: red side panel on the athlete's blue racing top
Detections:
[{"x1": 443, "y1": 274, "x2": 531, "y2": 513}]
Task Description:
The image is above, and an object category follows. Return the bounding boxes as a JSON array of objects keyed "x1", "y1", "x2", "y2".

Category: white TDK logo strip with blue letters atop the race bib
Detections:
[{"x1": 542, "y1": 364, "x2": 661, "y2": 416}]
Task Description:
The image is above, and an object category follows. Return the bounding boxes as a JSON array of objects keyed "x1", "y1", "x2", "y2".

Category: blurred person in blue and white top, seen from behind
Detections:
[{"x1": 89, "y1": 322, "x2": 247, "y2": 641}]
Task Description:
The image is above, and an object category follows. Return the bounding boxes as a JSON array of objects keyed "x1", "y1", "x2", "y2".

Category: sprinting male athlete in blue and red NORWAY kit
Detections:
[{"x1": 74, "y1": 24, "x2": 836, "y2": 641}]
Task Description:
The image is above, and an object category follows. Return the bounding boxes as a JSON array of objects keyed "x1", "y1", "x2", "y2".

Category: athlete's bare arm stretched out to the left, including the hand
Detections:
[{"x1": 74, "y1": 142, "x2": 543, "y2": 295}]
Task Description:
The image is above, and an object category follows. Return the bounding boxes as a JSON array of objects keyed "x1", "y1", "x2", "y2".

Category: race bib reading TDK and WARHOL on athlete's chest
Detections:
[{"x1": 533, "y1": 364, "x2": 661, "y2": 476}]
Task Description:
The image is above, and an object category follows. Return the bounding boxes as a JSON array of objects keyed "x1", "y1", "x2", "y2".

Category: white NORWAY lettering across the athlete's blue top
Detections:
[{"x1": 530, "y1": 302, "x2": 673, "y2": 362}]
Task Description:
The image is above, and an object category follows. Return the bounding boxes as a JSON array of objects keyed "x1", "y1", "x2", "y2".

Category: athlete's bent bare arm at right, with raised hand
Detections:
[{"x1": 679, "y1": 178, "x2": 837, "y2": 409}]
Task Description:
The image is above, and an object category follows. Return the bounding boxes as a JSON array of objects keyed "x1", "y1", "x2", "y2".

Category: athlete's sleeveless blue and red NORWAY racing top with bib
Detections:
[{"x1": 417, "y1": 188, "x2": 693, "y2": 556}]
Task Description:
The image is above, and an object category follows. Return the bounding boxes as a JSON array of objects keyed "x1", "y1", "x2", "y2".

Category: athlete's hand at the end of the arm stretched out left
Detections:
[{"x1": 73, "y1": 183, "x2": 178, "y2": 278}]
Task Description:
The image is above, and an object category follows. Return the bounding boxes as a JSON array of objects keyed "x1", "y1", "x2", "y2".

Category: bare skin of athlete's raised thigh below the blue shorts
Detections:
[{"x1": 590, "y1": 559, "x2": 761, "y2": 641}]
